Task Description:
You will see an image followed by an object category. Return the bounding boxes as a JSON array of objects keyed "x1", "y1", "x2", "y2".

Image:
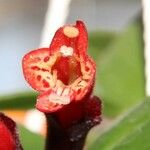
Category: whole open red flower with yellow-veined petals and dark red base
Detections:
[{"x1": 23, "y1": 21, "x2": 100, "y2": 126}]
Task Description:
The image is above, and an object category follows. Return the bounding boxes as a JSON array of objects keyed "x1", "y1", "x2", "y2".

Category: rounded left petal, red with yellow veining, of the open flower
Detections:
[{"x1": 22, "y1": 48, "x2": 51, "y2": 92}]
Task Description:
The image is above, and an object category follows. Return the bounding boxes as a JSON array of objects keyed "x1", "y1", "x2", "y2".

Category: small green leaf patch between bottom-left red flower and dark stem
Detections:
[{"x1": 19, "y1": 126, "x2": 45, "y2": 150}]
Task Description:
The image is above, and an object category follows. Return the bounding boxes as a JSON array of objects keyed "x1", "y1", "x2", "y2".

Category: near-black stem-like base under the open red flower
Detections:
[{"x1": 45, "y1": 114, "x2": 87, "y2": 150}]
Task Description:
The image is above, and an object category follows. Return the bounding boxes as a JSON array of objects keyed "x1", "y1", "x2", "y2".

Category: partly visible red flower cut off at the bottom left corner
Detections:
[{"x1": 0, "y1": 113, "x2": 22, "y2": 150}]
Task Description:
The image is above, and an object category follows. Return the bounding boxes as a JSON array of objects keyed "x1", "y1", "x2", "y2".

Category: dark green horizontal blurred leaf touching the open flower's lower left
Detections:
[{"x1": 0, "y1": 92, "x2": 36, "y2": 110}]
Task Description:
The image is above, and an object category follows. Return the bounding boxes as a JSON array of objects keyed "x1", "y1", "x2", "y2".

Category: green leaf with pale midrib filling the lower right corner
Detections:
[{"x1": 88, "y1": 98, "x2": 150, "y2": 150}]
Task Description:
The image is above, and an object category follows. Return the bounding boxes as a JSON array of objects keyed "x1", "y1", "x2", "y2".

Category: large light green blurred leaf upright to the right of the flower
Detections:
[{"x1": 95, "y1": 23, "x2": 145, "y2": 117}]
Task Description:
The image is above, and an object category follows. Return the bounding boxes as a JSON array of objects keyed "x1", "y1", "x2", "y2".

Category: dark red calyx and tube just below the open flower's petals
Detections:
[{"x1": 55, "y1": 96, "x2": 102, "y2": 128}]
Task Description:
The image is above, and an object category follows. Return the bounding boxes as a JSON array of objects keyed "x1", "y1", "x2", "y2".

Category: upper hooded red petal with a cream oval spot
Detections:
[{"x1": 50, "y1": 21, "x2": 88, "y2": 55}]
